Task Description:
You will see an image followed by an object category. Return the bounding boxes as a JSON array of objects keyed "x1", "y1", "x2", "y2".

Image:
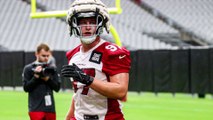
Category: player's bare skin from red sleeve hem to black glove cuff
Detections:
[{"x1": 90, "y1": 73, "x2": 129, "y2": 100}]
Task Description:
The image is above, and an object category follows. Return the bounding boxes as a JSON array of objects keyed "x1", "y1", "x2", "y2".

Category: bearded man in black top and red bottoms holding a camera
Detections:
[{"x1": 22, "y1": 44, "x2": 61, "y2": 120}]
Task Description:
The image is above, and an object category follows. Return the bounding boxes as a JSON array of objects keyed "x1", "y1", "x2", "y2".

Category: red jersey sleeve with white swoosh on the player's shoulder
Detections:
[{"x1": 103, "y1": 45, "x2": 131, "y2": 76}]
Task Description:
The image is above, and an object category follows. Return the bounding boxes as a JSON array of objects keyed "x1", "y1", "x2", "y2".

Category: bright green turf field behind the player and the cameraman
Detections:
[{"x1": 0, "y1": 91, "x2": 213, "y2": 120}]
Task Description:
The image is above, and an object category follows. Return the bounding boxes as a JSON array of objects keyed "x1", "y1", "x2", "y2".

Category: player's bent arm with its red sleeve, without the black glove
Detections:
[{"x1": 90, "y1": 45, "x2": 131, "y2": 100}]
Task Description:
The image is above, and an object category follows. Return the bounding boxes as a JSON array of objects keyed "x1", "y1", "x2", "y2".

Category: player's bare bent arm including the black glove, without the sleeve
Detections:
[{"x1": 61, "y1": 64, "x2": 129, "y2": 99}]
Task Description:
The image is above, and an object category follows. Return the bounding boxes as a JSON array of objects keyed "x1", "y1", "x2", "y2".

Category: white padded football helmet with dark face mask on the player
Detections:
[{"x1": 67, "y1": 0, "x2": 109, "y2": 44}]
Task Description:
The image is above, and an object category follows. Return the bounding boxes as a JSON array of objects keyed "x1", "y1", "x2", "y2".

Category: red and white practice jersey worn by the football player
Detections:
[{"x1": 66, "y1": 40, "x2": 130, "y2": 120}]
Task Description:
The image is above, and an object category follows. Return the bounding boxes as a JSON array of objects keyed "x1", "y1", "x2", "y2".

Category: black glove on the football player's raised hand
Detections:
[{"x1": 61, "y1": 63, "x2": 94, "y2": 85}]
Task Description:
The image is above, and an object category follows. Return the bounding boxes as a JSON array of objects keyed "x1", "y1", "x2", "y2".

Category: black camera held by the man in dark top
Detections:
[{"x1": 32, "y1": 63, "x2": 56, "y2": 77}]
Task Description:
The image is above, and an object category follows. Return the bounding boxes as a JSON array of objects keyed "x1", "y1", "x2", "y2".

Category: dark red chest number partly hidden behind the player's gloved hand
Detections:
[{"x1": 72, "y1": 68, "x2": 95, "y2": 95}]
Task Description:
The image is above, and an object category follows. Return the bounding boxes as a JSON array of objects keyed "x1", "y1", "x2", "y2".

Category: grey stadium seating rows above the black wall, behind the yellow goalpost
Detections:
[{"x1": 0, "y1": 0, "x2": 213, "y2": 51}]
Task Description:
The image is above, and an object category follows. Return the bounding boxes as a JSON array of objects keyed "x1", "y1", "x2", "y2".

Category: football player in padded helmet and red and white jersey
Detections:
[{"x1": 61, "y1": 0, "x2": 131, "y2": 120}]
